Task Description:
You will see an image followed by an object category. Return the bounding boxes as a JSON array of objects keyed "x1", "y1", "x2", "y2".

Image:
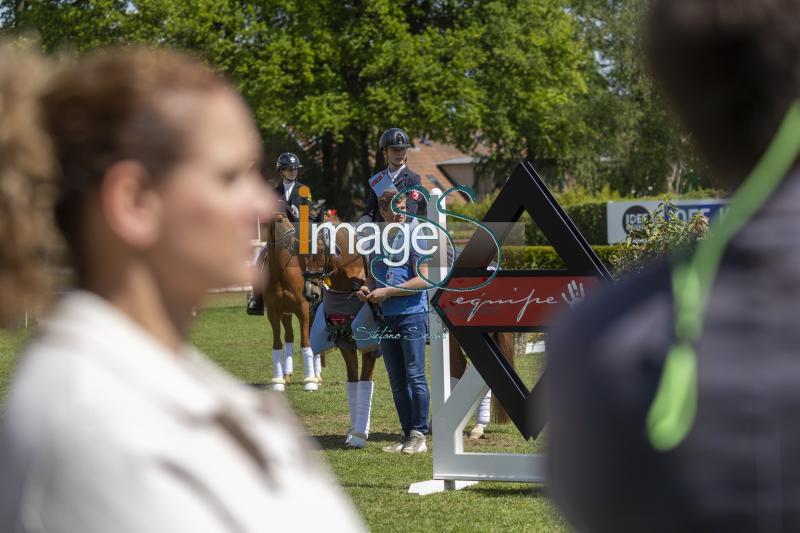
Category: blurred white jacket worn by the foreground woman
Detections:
[{"x1": 0, "y1": 292, "x2": 364, "y2": 533}]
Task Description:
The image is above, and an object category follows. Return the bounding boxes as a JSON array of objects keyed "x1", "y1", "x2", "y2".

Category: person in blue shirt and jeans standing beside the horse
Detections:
[{"x1": 358, "y1": 189, "x2": 430, "y2": 454}]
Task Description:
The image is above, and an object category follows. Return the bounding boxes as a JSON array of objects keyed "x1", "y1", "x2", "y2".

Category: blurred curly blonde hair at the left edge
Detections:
[{"x1": 0, "y1": 43, "x2": 54, "y2": 325}]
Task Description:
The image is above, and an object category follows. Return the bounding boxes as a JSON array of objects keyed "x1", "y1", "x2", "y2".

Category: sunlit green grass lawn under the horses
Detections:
[{"x1": 0, "y1": 294, "x2": 569, "y2": 533}]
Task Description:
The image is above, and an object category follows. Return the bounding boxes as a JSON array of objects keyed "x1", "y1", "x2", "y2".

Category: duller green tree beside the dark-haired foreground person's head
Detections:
[{"x1": 566, "y1": 0, "x2": 708, "y2": 196}]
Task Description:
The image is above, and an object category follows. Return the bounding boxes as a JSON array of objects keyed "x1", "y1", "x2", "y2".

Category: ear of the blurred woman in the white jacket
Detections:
[{"x1": 100, "y1": 160, "x2": 163, "y2": 249}]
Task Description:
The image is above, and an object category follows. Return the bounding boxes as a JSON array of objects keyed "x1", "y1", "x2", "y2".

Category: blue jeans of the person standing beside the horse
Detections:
[{"x1": 381, "y1": 313, "x2": 430, "y2": 437}]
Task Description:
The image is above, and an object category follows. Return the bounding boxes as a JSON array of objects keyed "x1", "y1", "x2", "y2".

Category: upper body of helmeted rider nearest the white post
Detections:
[{"x1": 359, "y1": 128, "x2": 427, "y2": 222}]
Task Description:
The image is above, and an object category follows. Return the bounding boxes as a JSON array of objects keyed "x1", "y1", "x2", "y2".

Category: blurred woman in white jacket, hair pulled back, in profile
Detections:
[{"x1": 0, "y1": 49, "x2": 362, "y2": 533}]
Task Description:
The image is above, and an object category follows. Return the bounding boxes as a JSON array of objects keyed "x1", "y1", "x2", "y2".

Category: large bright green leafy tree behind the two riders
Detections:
[{"x1": 0, "y1": 0, "x2": 589, "y2": 216}]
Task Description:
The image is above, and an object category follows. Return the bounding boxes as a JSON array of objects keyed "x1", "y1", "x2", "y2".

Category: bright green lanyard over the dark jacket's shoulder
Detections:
[{"x1": 647, "y1": 101, "x2": 800, "y2": 452}]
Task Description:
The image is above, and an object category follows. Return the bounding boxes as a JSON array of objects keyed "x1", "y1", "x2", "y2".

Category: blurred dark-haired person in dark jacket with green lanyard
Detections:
[{"x1": 547, "y1": 0, "x2": 800, "y2": 533}]
